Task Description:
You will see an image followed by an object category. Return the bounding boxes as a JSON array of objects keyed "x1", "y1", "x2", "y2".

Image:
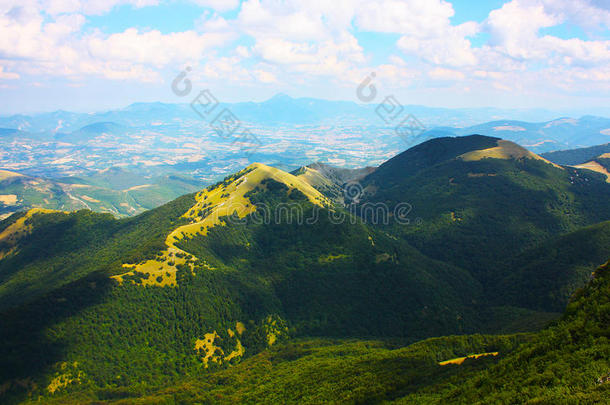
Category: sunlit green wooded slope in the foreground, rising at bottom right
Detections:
[{"x1": 21, "y1": 264, "x2": 610, "y2": 405}]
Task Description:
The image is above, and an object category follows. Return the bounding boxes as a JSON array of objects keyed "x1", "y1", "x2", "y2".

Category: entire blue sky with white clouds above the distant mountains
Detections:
[{"x1": 0, "y1": 0, "x2": 610, "y2": 114}]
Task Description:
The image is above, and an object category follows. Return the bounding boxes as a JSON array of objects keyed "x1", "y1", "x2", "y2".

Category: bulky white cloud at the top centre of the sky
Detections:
[{"x1": 236, "y1": 0, "x2": 365, "y2": 81}]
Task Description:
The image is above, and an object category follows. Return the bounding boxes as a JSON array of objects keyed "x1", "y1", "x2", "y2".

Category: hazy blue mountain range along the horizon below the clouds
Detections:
[{"x1": 0, "y1": 94, "x2": 610, "y2": 153}]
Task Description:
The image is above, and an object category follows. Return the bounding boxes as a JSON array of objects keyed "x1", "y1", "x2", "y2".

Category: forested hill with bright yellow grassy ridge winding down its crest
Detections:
[{"x1": 0, "y1": 160, "x2": 481, "y2": 395}]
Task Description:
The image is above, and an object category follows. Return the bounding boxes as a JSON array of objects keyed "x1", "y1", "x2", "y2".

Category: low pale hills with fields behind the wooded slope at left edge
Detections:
[{"x1": 0, "y1": 168, "x2": 202, "y2": 217}]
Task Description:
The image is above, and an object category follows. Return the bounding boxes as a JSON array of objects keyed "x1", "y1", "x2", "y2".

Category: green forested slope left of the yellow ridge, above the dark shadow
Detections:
[{"x1": 0, "y1": 194, "x2": 195, "y2": 310}]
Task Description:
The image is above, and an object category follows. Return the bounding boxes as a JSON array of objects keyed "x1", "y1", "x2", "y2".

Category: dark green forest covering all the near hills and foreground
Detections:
[{"x1": 0, "y1": 136, "x2": 610, "y2": 404}]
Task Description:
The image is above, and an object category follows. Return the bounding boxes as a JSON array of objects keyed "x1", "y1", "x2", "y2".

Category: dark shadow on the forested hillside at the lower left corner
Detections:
[{"x1": 0, "y1": 273, "x2": 114, "y2": 404}]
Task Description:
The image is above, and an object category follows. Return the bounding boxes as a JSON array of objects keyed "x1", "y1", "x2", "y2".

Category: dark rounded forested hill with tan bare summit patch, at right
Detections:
[{"x1": 361, "y1": 135, "x2": 610, "y2": 285}]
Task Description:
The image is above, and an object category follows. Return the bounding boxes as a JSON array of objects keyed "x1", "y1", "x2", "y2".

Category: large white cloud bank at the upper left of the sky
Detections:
[{"x1": 0, "y1": 0, "x2": 232, "y2": 82}]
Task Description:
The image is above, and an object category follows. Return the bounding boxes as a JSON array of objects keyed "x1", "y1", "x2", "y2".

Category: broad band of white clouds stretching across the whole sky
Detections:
[{"x1": 0, "y1": 0, "x2": 610, "y2": 103}]
